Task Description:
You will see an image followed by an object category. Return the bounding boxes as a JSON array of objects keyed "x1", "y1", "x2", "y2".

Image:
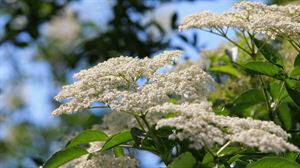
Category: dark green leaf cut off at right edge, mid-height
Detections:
[{"x1": 285, "y1": 79, "x2": 300, "y2": 106}]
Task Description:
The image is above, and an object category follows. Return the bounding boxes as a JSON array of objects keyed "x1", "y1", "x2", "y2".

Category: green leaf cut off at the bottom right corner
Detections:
[{"x1": 247, "y1": 156, "x2": 300, "y2": 168}]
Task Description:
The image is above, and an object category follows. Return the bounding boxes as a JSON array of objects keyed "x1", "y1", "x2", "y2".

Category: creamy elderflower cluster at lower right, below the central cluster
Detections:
[{"x1": 154, "y1": 101, "x2": 300, "y2": 154}]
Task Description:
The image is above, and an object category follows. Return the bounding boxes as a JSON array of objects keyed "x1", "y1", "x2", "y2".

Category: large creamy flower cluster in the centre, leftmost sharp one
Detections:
[{"x1": 52, "y1": 51, "x2": 211, "y2": 115}]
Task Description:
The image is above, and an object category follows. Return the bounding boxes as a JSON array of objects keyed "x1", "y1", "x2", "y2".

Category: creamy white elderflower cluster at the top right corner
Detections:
[{"x1": 179, "y1": 1, "x2": 300, "y2": 39}]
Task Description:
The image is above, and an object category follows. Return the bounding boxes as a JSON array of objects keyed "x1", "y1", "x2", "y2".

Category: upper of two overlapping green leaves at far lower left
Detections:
[{"x1": 66, "y1": 130, "x2": 108, "y2": 148}]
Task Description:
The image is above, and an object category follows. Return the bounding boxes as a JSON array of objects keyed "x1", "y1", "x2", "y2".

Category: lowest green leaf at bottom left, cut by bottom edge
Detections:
[{"x1": 43, "y1": 147, "x2": 88, "y2": 168}]
